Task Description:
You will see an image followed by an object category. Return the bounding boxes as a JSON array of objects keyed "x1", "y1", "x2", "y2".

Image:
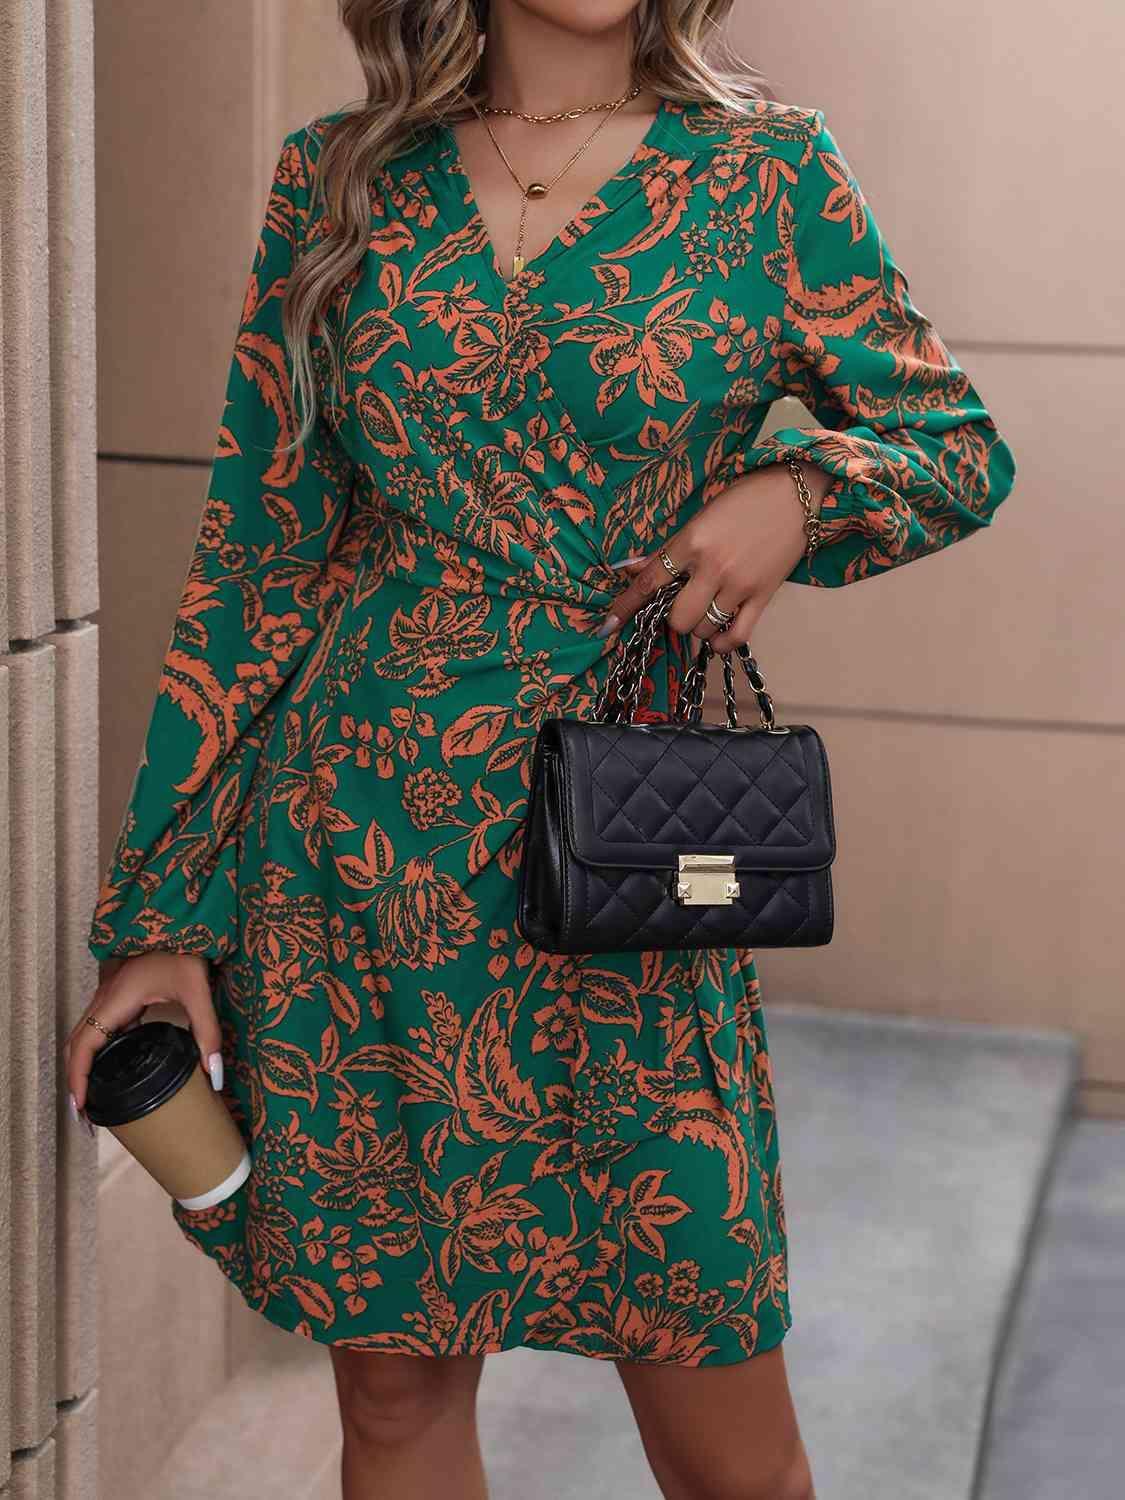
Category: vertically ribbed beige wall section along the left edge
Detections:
[{"x1": 0, "y1": 0, "x2": 98, "y2": 1500}]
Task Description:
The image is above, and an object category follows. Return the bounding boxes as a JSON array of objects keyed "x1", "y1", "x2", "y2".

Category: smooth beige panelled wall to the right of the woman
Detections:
[{"x1": 735, "y1": 0, "x2": 1125, "y2": 1115}]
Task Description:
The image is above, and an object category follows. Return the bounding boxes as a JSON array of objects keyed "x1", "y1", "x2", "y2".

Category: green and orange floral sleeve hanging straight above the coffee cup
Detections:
[{"x1": 89, "y1": 128, "x2": 354, "y2": 960}]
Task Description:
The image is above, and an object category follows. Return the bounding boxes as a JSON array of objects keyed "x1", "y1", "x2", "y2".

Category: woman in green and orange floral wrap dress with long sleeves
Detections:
[{"x1": 68, "y1": 0, "x2": 1014, "y2": 1500}]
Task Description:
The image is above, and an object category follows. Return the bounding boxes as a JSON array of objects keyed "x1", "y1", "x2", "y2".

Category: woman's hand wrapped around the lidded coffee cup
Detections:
[{"x1": 63, "y1": 950, "x2": 222, "y2": 1125}]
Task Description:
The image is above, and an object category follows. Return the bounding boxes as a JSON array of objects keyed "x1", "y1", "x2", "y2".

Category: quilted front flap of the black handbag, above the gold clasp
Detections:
[{"x1": 542, "y1": 719, "x2": 836, "y2": 872}]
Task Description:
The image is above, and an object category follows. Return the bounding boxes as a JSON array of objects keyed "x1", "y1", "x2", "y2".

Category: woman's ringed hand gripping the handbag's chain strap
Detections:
[{"x1": 599, "y1": 464, "x2": 831, "y2": 651}]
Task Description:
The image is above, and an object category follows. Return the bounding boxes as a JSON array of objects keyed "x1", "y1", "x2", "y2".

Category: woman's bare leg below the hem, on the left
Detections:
[{"x1": 330, "y1": 1347, "x2": 488, "y2": 1500}]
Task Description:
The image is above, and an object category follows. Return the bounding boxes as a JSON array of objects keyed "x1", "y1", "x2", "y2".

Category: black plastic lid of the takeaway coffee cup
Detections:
[{"x1": 86, "y1": 1022, "x2": 200, "y2": 1125}]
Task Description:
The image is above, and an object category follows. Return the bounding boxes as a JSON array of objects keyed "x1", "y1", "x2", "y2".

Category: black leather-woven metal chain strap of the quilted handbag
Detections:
[{"x1": 593, "y1": 578, "x2": 777, "y2": 729}]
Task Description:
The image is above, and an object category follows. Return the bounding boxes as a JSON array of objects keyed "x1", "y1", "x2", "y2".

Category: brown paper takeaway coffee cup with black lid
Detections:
[{"x1": 86, "y1": 1022, "x2": 251, "y2": 1209}]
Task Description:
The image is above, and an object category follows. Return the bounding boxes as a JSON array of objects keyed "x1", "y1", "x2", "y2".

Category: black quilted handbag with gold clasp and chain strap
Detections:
[{"x1": 516, "y1": 579, "x2": 836, "y2": 954}]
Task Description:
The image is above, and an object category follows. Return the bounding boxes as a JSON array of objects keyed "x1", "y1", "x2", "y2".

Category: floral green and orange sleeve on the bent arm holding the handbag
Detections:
[{"x1": 717, "y1": 110, "x2": 1016, "y2": 585}]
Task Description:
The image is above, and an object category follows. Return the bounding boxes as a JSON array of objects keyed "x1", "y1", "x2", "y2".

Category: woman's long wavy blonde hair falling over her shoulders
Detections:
[{"x1": 282, "y1": 0, "x2": 768, "y2": 447}]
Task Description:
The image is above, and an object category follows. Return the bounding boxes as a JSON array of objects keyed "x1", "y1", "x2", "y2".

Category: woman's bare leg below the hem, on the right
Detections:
[{"x1": 615, "y1": 1346, "x2": 816, "y2": 1500}]
